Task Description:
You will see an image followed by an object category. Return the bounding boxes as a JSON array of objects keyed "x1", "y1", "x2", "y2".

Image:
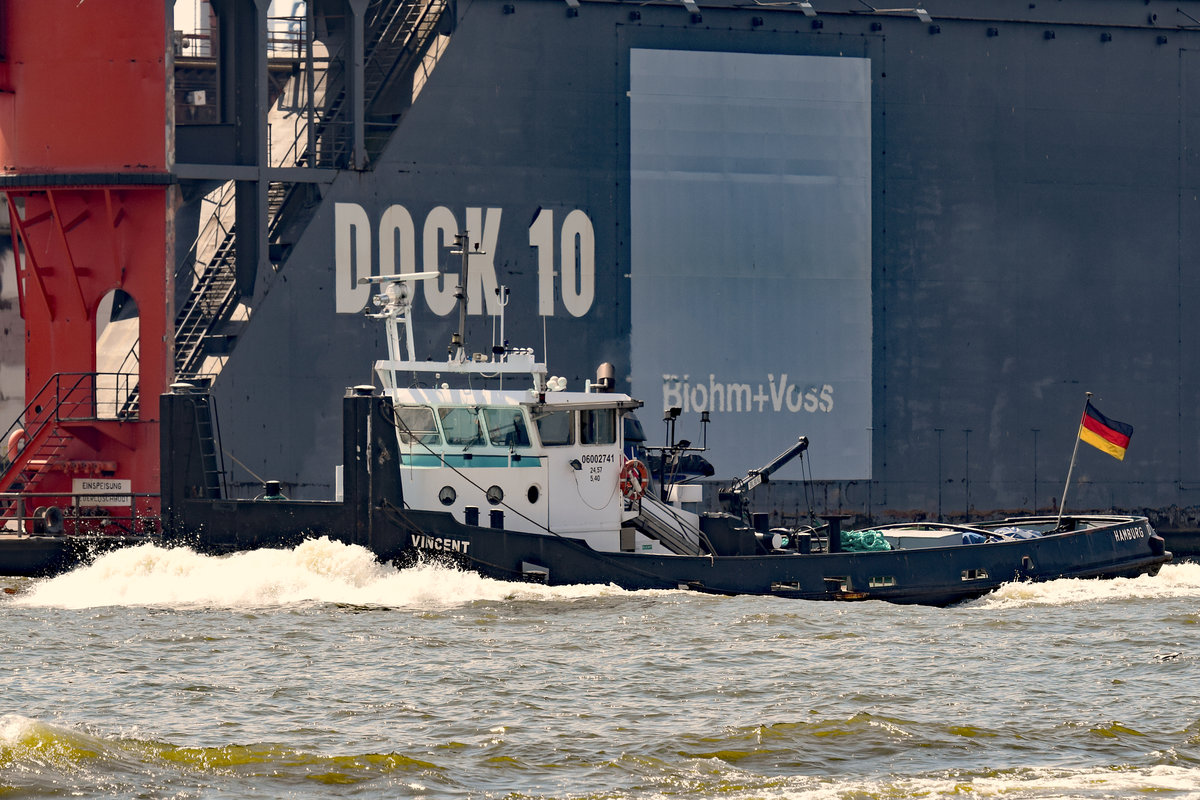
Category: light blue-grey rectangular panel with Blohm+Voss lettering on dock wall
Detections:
[{"x1": 630, "y1": 49, "x2": 871, "y2": 480}]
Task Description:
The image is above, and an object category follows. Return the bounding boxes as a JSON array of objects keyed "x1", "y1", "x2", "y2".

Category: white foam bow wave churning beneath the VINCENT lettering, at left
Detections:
[{"x1": 12, "y1": 539, "x2": 638, "y2": 608}]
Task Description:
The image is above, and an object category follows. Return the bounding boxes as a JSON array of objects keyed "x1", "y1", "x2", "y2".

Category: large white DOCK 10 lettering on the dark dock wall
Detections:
[{"x1": 334, "y1": 203, "x2": 596, "y2": 317}]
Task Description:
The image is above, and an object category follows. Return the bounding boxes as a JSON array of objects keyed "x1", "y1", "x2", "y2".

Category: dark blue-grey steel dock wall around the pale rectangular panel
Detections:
[{"x1": 201, "y1": 0, "x2": 1200, "y2": 527}]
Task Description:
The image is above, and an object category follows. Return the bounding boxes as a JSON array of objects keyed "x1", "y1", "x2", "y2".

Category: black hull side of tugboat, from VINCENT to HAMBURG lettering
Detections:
[{"x1": 374, "y1": 510, "x2": 1171, "y2": 606}]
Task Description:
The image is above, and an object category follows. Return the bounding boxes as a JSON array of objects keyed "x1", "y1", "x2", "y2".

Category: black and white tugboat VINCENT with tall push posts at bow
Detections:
[{"x1": 152, "y1": 241, "x2": 1171, "y2": 604}]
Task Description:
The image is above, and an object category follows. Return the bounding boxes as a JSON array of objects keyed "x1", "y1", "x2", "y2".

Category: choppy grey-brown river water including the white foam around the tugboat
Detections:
[{"x1": 0, "y1": 541, "x2": 1200, "y2": 800}]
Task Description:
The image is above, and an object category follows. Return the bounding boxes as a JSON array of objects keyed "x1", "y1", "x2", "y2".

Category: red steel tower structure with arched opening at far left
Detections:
[{"x1": 0, "y1": 0, "x2": 175, "y2": 533}]
